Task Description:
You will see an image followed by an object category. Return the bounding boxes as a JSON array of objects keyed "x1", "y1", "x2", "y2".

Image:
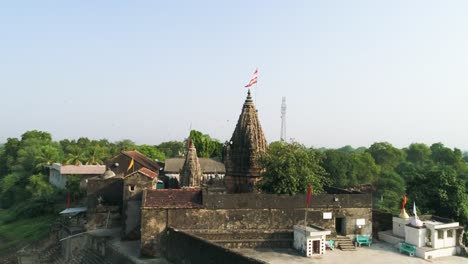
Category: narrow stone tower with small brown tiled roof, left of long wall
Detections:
[{"x1": 122, "y1": 168, "x2": 158, "y2": 239}]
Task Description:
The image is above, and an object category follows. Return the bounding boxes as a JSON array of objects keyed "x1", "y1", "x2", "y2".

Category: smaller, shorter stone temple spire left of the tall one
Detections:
[{"x1": 180, "y1": 141, "x2": 202, "y2": 187}]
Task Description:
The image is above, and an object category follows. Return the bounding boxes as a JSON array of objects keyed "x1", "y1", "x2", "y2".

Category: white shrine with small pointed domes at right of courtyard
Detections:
[{"x1": 379, "y1": 196, "x2": 463, "y2": 259}]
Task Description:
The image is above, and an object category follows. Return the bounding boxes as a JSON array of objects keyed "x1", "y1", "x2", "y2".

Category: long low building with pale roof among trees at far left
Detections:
[{"x1": 49, "y1": 163, "x2": 106, "y2": 189}]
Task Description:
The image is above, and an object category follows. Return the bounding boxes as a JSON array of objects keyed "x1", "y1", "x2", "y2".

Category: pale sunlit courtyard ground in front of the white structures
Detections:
[{"x1": 236, "y1": 242, "x2": 468, "y2": 264}]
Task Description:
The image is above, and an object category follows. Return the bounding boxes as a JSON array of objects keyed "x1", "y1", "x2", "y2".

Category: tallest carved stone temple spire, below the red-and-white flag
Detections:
[{"x1": 224, "y1": 90, "x2": 267, "y2": 193}]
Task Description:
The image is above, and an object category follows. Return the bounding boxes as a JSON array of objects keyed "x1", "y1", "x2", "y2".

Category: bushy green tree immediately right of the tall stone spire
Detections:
[{"x1": 257, "y1": 142, "x2": 328, "y2": 195}]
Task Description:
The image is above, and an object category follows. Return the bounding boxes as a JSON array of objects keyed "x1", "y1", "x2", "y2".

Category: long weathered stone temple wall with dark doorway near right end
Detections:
[{"x1": 141, "y1": 189, "x2": 372, "y2": 256}]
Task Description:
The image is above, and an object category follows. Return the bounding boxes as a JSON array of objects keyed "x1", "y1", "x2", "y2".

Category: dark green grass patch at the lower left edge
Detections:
[{"x1": 0, "y1": 209, "x2": 56, "y2": 256}]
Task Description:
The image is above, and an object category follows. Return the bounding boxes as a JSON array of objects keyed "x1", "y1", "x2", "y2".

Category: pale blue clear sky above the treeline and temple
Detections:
[{"x1": 0, "y1": 0, "x2": 468, "y2": 150}]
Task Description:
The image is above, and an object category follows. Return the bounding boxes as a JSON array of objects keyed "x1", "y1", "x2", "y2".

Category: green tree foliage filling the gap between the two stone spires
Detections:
[{"x1": 190, "y1": 130, "x2": 224, "y2": 158}]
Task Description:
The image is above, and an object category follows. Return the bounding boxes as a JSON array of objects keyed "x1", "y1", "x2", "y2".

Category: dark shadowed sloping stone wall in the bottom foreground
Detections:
[{"x1": 165, "y1": 228, "x2": 265, "y2": 264}]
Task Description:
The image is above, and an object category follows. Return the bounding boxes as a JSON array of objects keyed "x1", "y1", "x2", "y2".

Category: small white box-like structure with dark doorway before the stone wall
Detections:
[{"x1": 294, "y1": 225, "x2": 331, "y2": 257}]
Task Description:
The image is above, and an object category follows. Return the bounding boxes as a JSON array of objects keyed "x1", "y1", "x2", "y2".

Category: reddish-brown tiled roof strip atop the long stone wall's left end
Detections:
[{"x1": 143, "y1": 188, "x2": 203, "y2": 208}]
